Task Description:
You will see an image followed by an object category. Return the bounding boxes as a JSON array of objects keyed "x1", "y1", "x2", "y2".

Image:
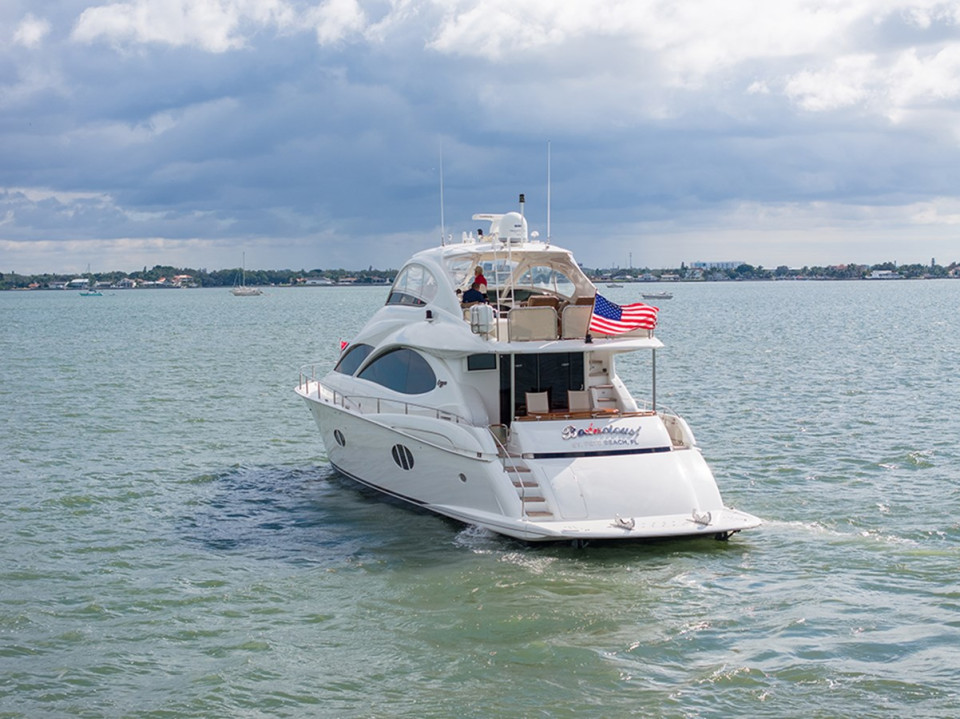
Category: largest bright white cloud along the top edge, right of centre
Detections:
[{"x1": 430, "y1": 0, "x2": 868, "y2": 78}]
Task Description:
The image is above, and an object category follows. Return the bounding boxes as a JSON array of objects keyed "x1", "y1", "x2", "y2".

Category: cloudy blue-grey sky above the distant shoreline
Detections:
[{"x1": 0, "y1": 0, "x2": 960, "y2": 273}]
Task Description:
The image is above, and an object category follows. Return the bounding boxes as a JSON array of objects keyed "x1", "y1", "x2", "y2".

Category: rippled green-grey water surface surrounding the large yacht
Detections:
[{"x1": 0, "y1": 281, "x2": 960, "y2": 718}]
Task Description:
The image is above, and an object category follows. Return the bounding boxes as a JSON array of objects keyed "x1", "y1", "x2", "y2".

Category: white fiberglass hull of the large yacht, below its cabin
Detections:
[{"x1": 298, "y1": 383, "x2": 760, "y2": 541}]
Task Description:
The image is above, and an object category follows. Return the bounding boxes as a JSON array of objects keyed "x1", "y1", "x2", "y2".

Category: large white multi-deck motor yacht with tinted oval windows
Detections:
[{"x1": 296, "y1": 196, "x2": 761, "y2": 543}]
